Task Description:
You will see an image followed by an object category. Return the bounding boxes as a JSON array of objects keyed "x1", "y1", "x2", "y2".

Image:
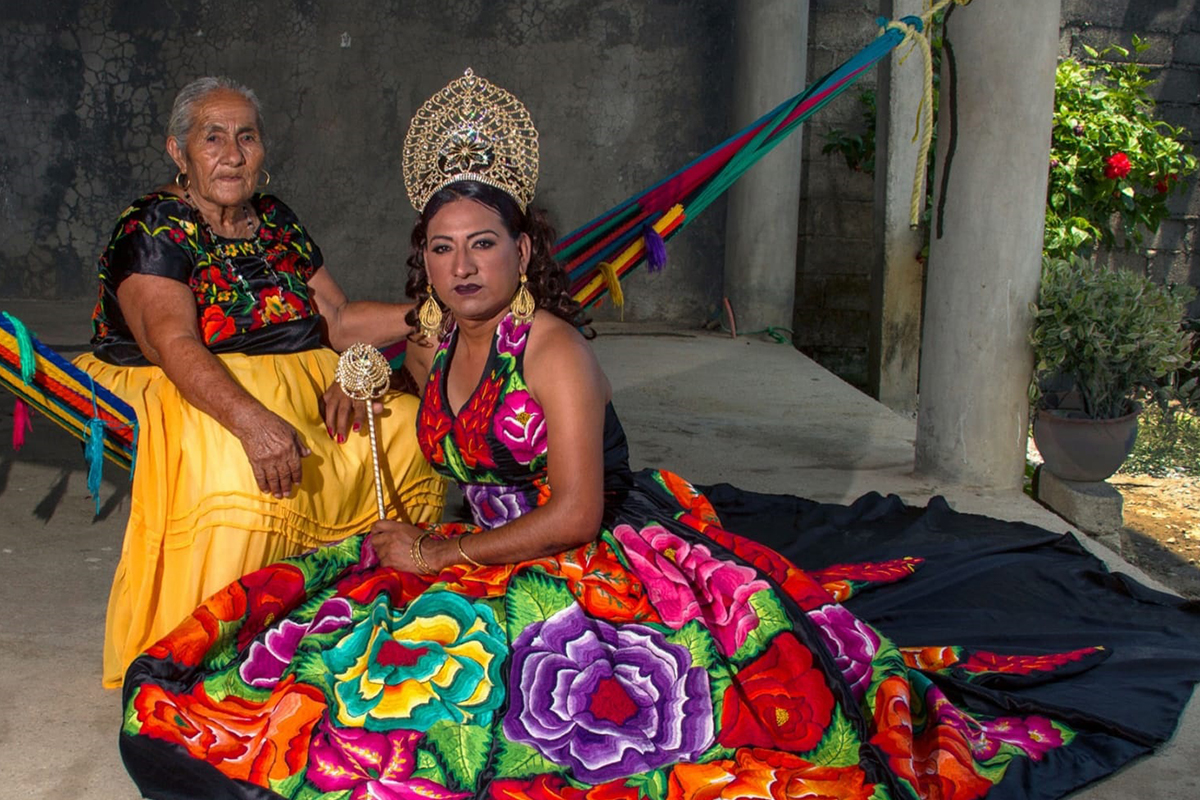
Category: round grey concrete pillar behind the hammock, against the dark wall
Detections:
[{"x1": 725, "y1": 0, "x2": 809, "y2": 331}]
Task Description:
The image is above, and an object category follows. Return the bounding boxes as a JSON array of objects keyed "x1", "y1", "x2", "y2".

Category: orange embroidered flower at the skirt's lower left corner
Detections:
[{"x1": 133, "y1": 675, "x2": 325, "y2": 787}]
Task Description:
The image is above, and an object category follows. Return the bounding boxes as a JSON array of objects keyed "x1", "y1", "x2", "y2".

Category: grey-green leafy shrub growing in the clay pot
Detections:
[{"x1": 1030, "y1": 255, "x2": 1195, "y2": 419}]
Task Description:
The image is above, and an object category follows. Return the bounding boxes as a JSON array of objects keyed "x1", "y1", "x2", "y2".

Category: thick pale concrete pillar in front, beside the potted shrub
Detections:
[{"x1": 916, "y1": 0, "x2": 1061, "y2": 489}]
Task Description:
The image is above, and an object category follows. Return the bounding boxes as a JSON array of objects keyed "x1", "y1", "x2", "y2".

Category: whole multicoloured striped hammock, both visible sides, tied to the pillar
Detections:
[{"x1": 0, "y1": 14, "x2": 916, "y2": 482}]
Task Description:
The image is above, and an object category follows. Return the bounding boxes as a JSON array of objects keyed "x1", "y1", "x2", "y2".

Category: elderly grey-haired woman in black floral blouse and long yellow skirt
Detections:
[{"x1": 78, "y1": 78, "x2": 443, "y2": 686}]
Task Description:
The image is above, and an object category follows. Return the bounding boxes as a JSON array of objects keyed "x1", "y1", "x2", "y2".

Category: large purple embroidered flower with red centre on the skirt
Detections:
[{"x1": 504, "y1": 606, "x2": 714, "y2": 783}]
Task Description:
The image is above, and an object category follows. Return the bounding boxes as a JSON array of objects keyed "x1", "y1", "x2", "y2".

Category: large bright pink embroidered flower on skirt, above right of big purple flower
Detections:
[{"x1": 613, "y1": 525, "x2": 768, "y2": 656}]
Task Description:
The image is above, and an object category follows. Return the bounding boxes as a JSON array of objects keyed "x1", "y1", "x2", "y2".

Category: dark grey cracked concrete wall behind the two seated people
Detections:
[{"x1": 0, "y1": 0, "x2": 732, "y2": 323}]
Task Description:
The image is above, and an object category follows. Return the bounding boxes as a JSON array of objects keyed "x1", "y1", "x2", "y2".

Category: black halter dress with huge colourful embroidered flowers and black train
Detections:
[{"x1": 114, "y1": 318, "x2": 1200, "y2": 800}]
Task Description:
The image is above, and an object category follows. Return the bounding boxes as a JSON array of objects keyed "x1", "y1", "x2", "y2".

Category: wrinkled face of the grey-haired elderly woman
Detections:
[{"x1": 168, "y1": 89, "x2": 266, "y2": 207}]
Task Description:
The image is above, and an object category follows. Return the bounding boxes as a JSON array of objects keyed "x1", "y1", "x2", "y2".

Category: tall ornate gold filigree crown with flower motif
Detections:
[{"x1": 404, "y1": 70, "x2": 538, "y2": 213}]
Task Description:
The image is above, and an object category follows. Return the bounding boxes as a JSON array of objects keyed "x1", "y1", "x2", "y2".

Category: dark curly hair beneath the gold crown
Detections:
[{"x1": 404, "y1": 181, "x2": 595, "y2": 338}]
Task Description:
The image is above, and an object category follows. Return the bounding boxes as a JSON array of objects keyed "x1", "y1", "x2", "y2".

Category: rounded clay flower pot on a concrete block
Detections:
[{"x1": 1033, "y1": 407, "x2": 1141, "y2": 481}]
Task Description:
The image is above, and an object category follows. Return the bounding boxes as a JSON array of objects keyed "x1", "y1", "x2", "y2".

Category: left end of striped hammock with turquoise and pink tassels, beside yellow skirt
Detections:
[{"x1": 0, "y1": 312, "x2": 138, "y2": 512}]
